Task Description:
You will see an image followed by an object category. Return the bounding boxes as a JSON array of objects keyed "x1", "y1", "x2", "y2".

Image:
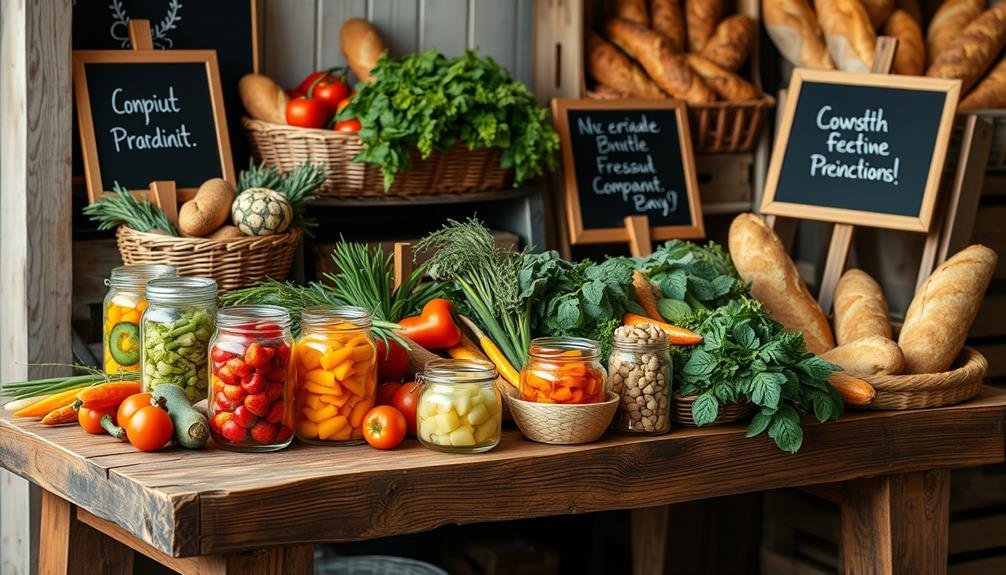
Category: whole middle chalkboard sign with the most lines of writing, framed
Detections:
[{"x1": 552, "y1": 100, "x2": 704, "y2": 243}]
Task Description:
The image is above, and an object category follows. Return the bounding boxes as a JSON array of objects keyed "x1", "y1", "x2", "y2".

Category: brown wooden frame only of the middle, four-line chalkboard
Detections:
[{"x1": 552, "y1": 99, "x2": 705, "y2": 244}]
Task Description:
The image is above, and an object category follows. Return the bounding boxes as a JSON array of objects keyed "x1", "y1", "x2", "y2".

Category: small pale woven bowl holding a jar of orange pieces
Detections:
[{"x1": 507, "y1": 392, "x2": 619, "y2": 445}]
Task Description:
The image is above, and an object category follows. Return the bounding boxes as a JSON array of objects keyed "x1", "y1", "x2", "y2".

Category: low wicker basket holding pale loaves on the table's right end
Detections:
[{"x1": 863, "y1": 348, "x2": 989, "y2": 409}]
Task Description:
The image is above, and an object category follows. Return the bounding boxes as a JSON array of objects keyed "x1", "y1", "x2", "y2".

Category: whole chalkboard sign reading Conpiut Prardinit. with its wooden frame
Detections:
[{"x1": 73, "y1": 50, "x2": 235, "y2": 201}]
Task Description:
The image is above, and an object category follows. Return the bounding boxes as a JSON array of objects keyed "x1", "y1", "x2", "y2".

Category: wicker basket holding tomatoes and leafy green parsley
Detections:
[{"x1": 241, "y1": 118, "x2": 513, "y2": 197}]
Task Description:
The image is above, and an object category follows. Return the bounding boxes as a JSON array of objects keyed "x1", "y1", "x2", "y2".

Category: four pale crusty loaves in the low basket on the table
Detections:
[{"x1": 729, "y1": 213, "x2": 997, "y2": 404}]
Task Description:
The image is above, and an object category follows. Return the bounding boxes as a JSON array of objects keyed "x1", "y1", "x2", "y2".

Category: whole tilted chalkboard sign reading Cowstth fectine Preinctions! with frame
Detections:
[{"x1": 762, "y1": 68, "x2": 961, "y2": 231}]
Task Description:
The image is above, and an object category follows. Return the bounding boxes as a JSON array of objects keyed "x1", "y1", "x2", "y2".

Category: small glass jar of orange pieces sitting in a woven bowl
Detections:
[{"x1": 520, "y1": 338, "x2": 608, "y2": 403}]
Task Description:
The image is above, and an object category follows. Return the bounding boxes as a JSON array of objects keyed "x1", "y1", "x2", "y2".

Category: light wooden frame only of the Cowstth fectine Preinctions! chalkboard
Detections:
[{"x1": 761, "y1": 68, "x2": 961, "y2": 232}]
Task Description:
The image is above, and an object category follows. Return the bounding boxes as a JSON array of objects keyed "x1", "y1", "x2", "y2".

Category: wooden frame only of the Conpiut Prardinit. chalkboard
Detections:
[{"x1": 73, "y1": 49, "x2": 237, "y2": 203}]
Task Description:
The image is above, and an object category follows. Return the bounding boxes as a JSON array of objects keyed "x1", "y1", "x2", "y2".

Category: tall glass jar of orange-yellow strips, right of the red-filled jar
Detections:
[{"x1": 288, "y1": 306, "x2": 377, "y2": 444}]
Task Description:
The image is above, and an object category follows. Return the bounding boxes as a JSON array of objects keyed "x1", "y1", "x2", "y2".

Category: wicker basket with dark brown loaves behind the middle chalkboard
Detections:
[{"x1": 584, "y1": 0, "x2": 775, "y2": 154}]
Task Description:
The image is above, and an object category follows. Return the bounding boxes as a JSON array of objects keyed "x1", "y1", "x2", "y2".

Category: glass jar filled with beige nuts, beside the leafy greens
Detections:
[{"x1": 608, "y1": 326, "x2": 674, "y2": 434}]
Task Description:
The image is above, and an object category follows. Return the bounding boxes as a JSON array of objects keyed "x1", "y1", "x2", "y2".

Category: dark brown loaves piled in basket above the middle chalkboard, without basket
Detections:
[{"x1": 585, "y1": 0, "x2": 762, "y2": 104}]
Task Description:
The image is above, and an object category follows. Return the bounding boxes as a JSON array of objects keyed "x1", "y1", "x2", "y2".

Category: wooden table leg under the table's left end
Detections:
[{"x1": 38, "y1": 491, "x2": 133, "y2": 575}]
